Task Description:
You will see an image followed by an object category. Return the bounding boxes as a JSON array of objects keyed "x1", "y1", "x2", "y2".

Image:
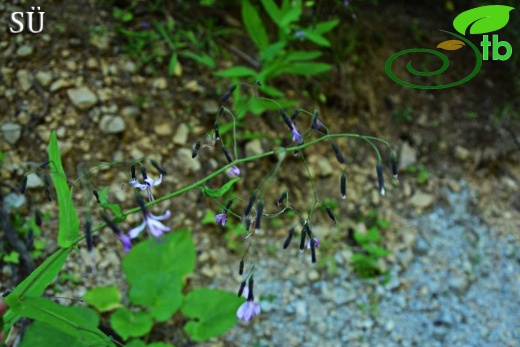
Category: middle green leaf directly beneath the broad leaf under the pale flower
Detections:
[{"x1": 129, "y1": 269, "x2": 182, "y2": 322}]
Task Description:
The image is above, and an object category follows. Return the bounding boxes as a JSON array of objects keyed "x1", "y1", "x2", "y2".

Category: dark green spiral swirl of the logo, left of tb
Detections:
[{"x1": 385, "y1": 30, "x2": 482, "y2": 89}]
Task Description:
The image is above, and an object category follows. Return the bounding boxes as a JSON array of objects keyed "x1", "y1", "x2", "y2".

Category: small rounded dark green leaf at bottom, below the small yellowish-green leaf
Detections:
[{"x1": 110, "y1": 307, "x2": 153, "y2": 340}]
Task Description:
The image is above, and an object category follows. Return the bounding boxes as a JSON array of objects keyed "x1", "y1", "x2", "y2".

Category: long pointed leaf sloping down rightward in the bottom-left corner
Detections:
[{"x1": 10, "y1": 296, "x2": 113, "y2": 346}]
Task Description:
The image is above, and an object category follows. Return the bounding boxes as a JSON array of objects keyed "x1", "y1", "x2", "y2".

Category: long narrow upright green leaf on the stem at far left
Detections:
[{"x1": 49, "y1": 131, "x2": 79, "y2": 248}]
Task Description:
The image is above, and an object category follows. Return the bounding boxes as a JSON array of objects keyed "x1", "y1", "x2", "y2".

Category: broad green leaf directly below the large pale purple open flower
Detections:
[{"x1": 123, "y1": 230, "x2": 195, "y2": 285}]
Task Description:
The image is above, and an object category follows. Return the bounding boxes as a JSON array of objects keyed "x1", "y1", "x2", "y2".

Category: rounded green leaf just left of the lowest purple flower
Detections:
[{"x1": 181, "y1": 288, "x2": 244, "y2": 341}]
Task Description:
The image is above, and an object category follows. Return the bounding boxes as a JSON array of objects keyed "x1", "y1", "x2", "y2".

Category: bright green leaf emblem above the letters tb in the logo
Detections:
[{"x1": 453, "y1": 5, "x2": 514, "y2": 35}]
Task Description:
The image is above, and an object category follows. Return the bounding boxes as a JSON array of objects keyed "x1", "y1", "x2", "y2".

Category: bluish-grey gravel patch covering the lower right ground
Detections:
[{"x1": 213, "y1": 182, "x2": 520, "y2": 346}]
